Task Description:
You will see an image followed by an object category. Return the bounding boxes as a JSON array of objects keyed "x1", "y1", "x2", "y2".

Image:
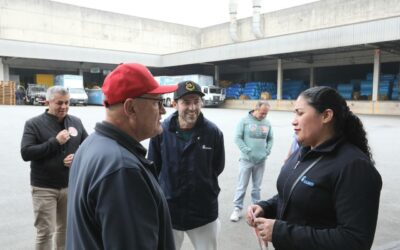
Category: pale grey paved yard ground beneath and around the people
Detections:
[{"x1": 0, "y1": 105, "x2": 400, "y2": 250}]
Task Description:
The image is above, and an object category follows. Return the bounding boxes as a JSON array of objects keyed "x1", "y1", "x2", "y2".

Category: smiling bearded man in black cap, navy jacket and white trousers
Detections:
[{"x1": 148, "y1": 81, "x2": 225, "y2": 250}]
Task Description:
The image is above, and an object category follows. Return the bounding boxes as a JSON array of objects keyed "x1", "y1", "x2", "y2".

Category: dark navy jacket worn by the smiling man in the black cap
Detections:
[{"x1": 148, "y1": 112, "x2": 225, "y2": 231}]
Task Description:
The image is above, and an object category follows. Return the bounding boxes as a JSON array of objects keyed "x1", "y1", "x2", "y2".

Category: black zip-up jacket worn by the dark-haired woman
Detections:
[{"x1": 258, "y1": 138, "x2": 382, "y2": 250}]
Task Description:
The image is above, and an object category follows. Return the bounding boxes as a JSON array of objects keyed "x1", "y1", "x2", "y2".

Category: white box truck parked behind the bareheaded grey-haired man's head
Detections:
[{"x1": 54, "y1": 75, "x2": 88, "y2": 106}]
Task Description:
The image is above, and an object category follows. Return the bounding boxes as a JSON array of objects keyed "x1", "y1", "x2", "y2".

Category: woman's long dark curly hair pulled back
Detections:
[{"x1": 300, "y1": 86, "x2": 373, "y2": 162}]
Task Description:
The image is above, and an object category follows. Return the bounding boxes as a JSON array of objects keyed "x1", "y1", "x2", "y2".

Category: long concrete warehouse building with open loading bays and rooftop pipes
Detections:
[{"x1": 0, "y1": 0, "x2": 400, "y2": 115}]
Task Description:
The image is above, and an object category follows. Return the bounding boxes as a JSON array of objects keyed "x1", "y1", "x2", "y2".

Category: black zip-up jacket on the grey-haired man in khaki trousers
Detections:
[{"x1": 21, "y1": 110, "x2": 88, "y2": 188}]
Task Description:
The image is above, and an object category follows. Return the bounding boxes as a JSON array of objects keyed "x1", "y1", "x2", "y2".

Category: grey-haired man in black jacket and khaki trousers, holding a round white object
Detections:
[{"x1": 21, "y1": 86, "x2": 88, "y2": 250}]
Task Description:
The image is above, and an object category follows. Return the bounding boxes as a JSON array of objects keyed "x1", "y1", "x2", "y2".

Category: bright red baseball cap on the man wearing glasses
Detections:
[{"x1": 102, "y1": 63, "x2": 178, "y2": 106}]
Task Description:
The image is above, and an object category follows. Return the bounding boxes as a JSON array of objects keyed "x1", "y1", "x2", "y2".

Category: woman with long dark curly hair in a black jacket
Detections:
[{"x1": 246, "y1": 87, "x2": 382, "y2": 250}]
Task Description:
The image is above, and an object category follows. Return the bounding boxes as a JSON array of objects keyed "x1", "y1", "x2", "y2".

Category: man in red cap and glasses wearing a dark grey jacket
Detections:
[{"x1": 67, "y1": 63, "x2": 177, "y2": 250}]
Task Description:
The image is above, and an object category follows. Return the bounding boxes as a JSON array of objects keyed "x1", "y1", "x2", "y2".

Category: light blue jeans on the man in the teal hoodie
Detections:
[{"x1": 233, "y1": 160, "x2": 265, "y2": 209}]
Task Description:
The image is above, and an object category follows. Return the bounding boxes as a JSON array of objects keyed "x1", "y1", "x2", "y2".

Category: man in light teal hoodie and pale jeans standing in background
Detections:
[{"x1": 230, "y1": 101, "x2": 274, "y2": 222}]
